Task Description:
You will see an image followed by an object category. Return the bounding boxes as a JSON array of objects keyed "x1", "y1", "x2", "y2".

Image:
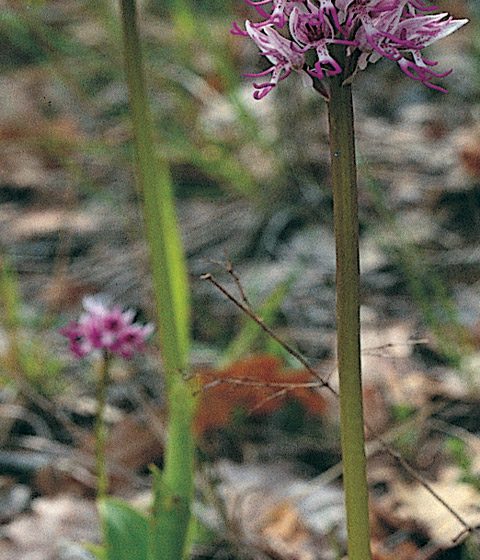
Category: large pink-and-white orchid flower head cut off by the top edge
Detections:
[{"x1": 231, "y1": 0, "x2": 468, "y2": 99}]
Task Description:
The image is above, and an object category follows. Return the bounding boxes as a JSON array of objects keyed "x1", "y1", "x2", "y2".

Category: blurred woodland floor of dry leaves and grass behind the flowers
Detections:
[{"x1": 0, "y1": 0, "x2": 480, "y2": 560}]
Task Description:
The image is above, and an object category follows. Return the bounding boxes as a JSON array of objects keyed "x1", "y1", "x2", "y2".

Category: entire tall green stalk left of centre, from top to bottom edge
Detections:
[{"x1": 120, "y1": 0, "x2": 195, "y2": 560}]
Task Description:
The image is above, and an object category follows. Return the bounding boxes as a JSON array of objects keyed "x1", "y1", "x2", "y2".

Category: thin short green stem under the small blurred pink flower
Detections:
[{"x1": 95, "y1": 352, "x2": 109, "y2": 500}]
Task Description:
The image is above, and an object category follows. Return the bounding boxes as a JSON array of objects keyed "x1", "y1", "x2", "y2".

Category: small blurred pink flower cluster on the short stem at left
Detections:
[{"x1": 60, "y1": 296, "x2": 153, "y2": 359}]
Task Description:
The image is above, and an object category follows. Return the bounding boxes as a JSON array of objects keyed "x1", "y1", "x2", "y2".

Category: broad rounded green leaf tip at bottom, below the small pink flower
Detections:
[{"x1": 97, "y1": 498, "x2": 149, "y2": 560}]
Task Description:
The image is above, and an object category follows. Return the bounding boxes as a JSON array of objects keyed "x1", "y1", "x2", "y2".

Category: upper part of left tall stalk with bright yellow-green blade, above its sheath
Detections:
[{"x1": 122, "y1": 0, "x2": 190, "y2": 378}]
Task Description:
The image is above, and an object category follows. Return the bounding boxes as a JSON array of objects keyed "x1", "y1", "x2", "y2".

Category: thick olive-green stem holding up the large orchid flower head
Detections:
[{"x1": 328, "y1": 61, "x2": 371, "y2": 560}]
